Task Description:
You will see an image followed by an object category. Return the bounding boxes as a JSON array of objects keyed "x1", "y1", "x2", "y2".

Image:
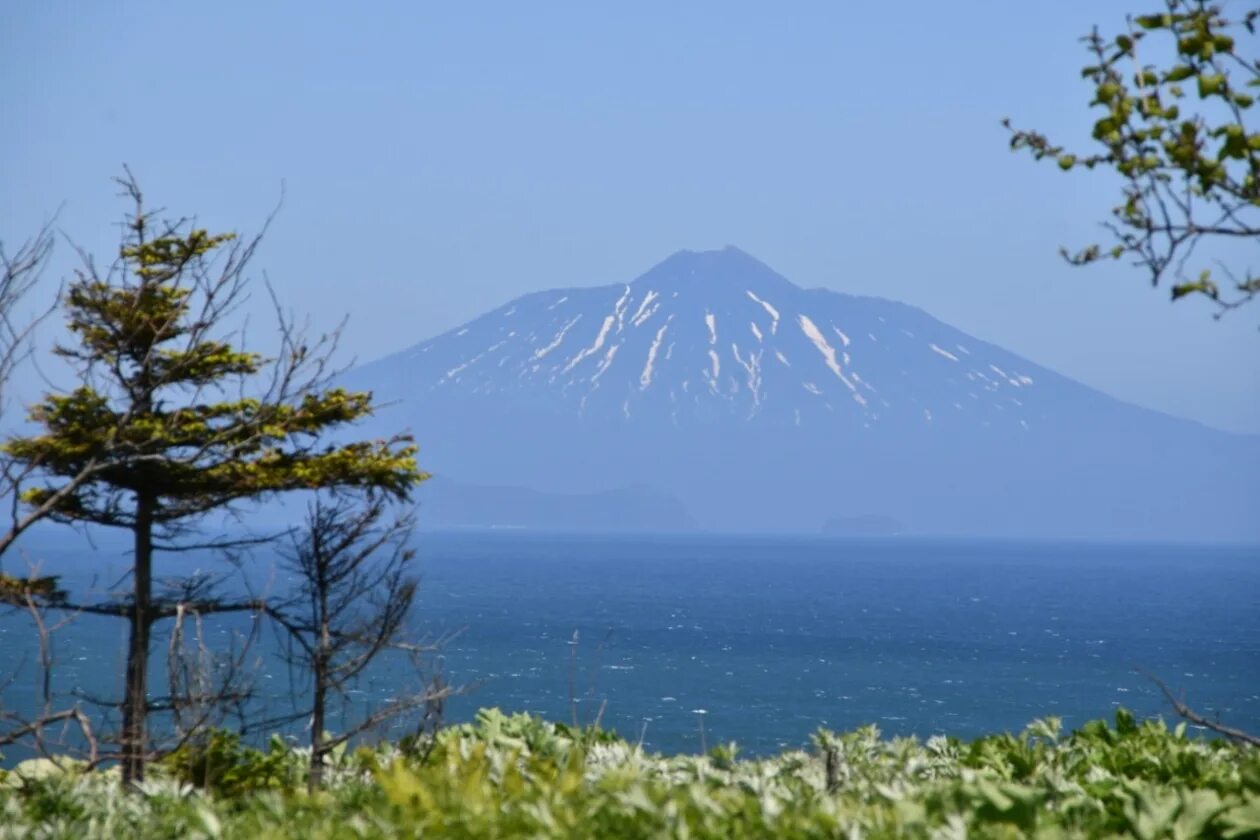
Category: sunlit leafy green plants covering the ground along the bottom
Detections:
[{"x1": 0, "y1": 710, "x2": 1260, "y2": 839}]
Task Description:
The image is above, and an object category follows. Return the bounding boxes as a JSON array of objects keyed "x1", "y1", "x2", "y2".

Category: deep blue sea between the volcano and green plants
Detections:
[{"x1": 0, "y1": 533, "x2": 1260, "y2": 753}]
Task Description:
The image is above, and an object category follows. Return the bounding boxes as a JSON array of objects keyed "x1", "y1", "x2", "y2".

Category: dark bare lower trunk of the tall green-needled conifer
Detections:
[{"x1": 120, "y1": 494, "x2": 156, "y2": 786}]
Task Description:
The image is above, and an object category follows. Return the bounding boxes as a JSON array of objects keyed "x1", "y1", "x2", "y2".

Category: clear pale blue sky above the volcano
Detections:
[{"x1": 0, "y1": 0, "x2": 1260, "y2": 432}]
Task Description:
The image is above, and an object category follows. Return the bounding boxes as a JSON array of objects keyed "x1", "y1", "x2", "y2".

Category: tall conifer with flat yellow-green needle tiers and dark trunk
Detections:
[{"x1": 4, "y1": 171, "x2": 426, "y2": 783}]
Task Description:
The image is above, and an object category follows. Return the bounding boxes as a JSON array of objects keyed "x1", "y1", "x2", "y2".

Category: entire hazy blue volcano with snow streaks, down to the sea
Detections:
[{"x1": 352, "y1": 248, "x2": 1260, "y2": 536}]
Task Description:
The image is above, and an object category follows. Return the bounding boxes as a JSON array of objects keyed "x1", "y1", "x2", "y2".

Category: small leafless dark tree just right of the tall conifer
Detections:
[{"x1": 272, "y1": 494, "x2": 451, "y2": 790}]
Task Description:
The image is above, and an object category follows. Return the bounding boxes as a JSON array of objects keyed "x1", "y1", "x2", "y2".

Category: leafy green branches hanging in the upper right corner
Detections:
[{"x1": 1004, "y1": 0, "x2": 1260, "y2": 314}]
